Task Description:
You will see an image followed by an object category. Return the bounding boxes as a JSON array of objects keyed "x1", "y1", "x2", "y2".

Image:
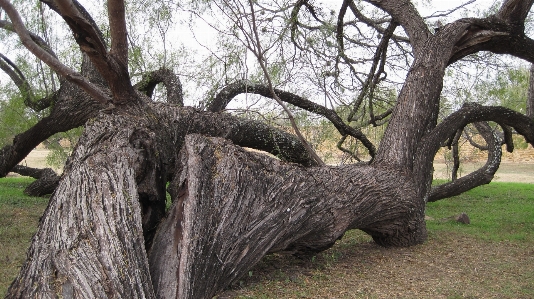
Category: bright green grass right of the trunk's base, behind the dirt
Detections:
[{"x1": 426, "y1": 183, "x2": 534, "y2": 242}]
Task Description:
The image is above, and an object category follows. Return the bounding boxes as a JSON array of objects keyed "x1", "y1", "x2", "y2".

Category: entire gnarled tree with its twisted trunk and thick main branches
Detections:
[{"x1": 5, "y1": 0, "x2": 534, "y2": 299}]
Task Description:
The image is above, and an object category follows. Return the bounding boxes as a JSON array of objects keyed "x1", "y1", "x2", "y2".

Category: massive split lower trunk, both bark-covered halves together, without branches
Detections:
[{"x1": 8, "y1": 105, "x2": 426, "y2": 298}]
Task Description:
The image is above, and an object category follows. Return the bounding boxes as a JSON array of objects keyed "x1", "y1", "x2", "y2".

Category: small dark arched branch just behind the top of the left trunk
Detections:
[{"x1": 134, "y1": 67, "x2": 184, "y2": 106}]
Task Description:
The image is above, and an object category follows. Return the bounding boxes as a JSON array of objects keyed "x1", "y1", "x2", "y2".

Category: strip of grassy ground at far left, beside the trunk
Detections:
[{"x1": 0, "y1": 177, "x2": 48, "y2": 297}]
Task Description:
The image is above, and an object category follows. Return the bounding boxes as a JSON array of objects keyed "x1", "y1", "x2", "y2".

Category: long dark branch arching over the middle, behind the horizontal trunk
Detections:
[{"x1": 207, "y1": 80, "x2": 376, "y2": 157}]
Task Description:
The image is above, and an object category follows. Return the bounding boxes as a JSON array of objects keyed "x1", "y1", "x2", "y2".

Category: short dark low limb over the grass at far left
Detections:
[{"x1": 12, "y1": 165, "x2": 60, "y2": 196}]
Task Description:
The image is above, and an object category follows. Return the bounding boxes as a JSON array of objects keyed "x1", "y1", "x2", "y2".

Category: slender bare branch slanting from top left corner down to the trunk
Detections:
[{"x1": 0, "y1": 0, "x2": 111, "y2": 103}]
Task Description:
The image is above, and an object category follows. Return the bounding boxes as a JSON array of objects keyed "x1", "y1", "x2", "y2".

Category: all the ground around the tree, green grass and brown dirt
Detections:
[{"x1": 0, "y1": 178, "x2": 534, "y2": 299}]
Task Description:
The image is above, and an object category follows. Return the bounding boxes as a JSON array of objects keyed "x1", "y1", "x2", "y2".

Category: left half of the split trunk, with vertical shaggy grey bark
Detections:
[{"x1": 7, "y1": 115, "x2": 160, "y2": 298}]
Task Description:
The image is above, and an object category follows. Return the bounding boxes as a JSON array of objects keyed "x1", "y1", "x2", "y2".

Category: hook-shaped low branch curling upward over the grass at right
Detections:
[{"x1": 428, "y1": 122, "x2": 502, "y2": 202}]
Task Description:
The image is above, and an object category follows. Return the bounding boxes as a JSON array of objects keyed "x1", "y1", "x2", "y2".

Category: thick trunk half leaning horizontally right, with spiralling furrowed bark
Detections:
[{"x1": 149, "y1": 135, "x2": 426, "y2": 298}]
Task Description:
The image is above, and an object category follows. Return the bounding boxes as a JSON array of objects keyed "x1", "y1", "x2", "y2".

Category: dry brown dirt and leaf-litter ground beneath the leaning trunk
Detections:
[{"x1": 220, "y1": 232, "x2": 534, "y2": 298}]
